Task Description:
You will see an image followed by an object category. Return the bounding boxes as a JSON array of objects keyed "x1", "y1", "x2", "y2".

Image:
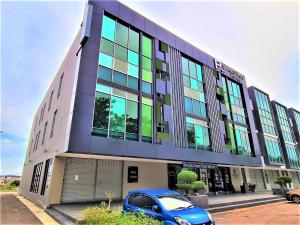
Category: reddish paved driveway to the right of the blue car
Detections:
[{"x1": 212, "y1": 201, "x2": 300, "y2": 225}]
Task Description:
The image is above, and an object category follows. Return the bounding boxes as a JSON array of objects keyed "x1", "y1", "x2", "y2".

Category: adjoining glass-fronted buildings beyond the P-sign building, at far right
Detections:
[{"x1": 248, "y1": 86, "x2": 300, "y2": 189}]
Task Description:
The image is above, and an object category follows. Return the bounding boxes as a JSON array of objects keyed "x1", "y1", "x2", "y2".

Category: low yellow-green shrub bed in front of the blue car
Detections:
[{"x1": 79, "y1": 206, "x2": 162, "y2": 225}]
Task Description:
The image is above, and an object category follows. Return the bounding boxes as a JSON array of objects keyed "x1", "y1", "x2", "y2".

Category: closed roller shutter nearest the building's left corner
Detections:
[{"x1": 61, "y1": 158, "x2": 96, "y2": 202}]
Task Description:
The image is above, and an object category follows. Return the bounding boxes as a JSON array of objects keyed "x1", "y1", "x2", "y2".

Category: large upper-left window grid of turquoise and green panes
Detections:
[{"x1": 98, "y1": 15, "x2": 139, "y2": 90}]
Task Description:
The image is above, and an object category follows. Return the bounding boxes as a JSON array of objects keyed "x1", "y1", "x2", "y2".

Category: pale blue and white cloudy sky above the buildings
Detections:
[{"x1": 0, "y1": 0, "x2": 300, "y2": 175}]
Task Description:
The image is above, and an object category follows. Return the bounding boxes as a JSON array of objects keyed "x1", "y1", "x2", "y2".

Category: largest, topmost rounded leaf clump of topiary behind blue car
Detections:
[{"x1": 176, "y1": 170, "x2": 197, "y2": 194}]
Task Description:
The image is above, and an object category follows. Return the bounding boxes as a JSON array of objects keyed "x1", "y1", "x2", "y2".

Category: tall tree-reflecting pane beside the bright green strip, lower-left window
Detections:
[{"x1": 126, "y1": 100, "x2": 138, "y2": 140}]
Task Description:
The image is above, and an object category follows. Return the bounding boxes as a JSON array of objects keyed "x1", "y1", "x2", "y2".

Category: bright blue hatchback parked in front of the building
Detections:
[{"x1": 123, "y1": 190, "x2": 215, "y2": 225}]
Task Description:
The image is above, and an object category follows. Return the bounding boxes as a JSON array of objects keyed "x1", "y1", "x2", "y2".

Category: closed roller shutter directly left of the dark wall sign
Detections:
[{"x1": 95, "y1": 160, "x2": 123, "y2": 199}]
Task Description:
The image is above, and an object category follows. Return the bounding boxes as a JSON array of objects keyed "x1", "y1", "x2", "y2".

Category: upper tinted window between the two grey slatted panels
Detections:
[{"x1": 181, "y1": 56, "x2": 207, "y2": 118}]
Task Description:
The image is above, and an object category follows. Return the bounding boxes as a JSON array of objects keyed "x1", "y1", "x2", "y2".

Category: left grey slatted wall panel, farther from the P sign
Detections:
[{"x1": 170, "y1": 47, "x2": 187, "y2": 148}]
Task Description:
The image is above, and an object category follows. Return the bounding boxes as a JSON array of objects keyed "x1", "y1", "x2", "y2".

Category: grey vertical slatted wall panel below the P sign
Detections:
[{"x1": 203, "y1": 66, "x2": 225, "y2": 152}]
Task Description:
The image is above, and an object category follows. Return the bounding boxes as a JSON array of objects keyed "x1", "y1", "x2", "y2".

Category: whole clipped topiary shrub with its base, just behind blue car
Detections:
[{"x1": 176, "y1": 169, "x2": 208, "y2": 208}]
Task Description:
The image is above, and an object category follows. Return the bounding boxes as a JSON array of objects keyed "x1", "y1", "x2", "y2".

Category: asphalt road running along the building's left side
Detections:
[{"x1": 0, "y1": 193, "x2": 42, "y2": 225}]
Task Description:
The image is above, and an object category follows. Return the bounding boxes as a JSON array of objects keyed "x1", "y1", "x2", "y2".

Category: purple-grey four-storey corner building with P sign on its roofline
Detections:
[{"x1": 21, "y1": 1, "x2": 298, "y2": 207}]
